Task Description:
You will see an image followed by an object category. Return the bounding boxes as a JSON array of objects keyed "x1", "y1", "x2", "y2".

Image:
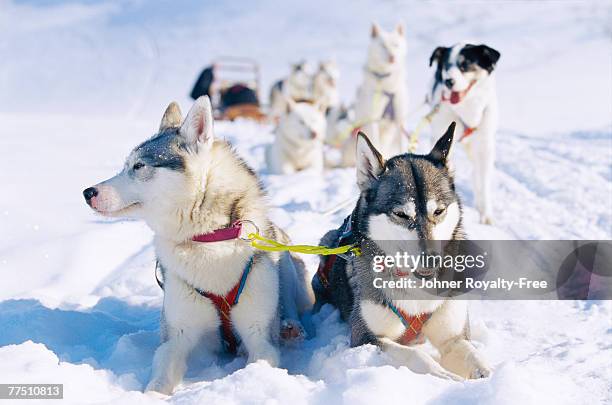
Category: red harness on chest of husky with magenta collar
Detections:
[{"x1": 195, "y1": 256, "x2": 253, "y2": 354}]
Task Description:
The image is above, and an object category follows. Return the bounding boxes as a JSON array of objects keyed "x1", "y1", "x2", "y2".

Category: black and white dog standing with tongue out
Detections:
[{"x1": 427, "y1": 43, "x2": 500, "y2": 224}]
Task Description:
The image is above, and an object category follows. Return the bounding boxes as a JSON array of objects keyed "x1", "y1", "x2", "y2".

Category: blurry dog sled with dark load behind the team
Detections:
[{"x1": 191, "y1": 56, "x2": 267, "y2": 122}]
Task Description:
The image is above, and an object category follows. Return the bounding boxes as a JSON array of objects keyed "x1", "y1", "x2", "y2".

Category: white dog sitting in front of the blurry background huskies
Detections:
[{"x1": 266, "y1": 99, "x2": 326, "y2": 174}]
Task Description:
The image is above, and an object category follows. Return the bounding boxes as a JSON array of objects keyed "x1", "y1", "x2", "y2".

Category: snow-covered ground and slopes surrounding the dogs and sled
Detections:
[{"x1": 0, "y1": 0, "x2": 612, "y2": 404}]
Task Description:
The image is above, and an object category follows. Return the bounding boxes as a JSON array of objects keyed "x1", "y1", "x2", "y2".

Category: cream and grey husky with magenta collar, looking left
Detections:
[{"x1": 83, "y1": 96, "x2": 311, "y2": 394}]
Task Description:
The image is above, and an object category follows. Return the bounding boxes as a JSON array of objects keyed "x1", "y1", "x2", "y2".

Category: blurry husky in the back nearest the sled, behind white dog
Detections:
[{"x1": 270, "y1": 62, "x2": 312, "y2": 119}]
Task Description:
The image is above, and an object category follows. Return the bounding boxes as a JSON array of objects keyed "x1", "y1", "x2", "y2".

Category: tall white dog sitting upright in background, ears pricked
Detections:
[{"x1": 343, "y1": 24, "x2": 407, "y2": 166}]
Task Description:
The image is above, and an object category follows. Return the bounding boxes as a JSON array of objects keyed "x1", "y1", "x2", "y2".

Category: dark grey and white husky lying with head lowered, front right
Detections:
[{"x1": 312, "y1": 123, "x2": 490, "y2": 379}]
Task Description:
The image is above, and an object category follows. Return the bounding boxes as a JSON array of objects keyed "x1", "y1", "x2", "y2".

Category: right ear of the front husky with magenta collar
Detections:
[{"x1": 181, "y1": 96, "x2": 214, "y2": 150}]
